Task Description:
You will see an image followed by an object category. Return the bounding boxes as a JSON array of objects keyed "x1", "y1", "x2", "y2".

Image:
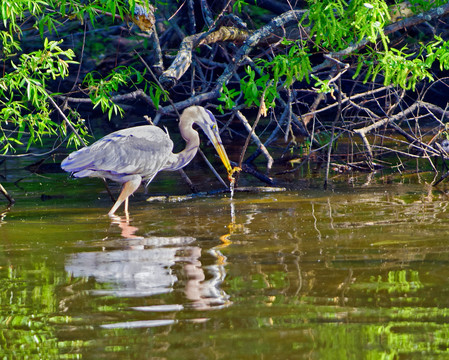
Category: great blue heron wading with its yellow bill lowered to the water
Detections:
[{"x1": 61, "y1": 106, "x2": 233, "y2": 216}]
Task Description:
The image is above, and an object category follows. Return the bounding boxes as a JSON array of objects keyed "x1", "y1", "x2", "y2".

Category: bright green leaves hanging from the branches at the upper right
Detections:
[{"x1": 219, "y1": 0, "x2": 449, "y2": 109}]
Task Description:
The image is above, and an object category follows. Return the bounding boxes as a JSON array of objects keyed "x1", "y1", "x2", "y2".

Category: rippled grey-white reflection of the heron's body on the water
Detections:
[{"x1": 65, "y1": 236, "x2": 232, "y2": 311}]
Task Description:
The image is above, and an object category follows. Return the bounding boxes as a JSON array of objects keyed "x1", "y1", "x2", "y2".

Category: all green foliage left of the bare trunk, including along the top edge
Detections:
[{"x1": 0, "y1": 0, "x2": 140, "y2": 153}]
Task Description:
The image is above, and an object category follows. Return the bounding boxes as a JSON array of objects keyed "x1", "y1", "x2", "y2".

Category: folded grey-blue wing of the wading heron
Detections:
[{"x1": 61, "y1": 125, "x2": 173, "y2": 180}]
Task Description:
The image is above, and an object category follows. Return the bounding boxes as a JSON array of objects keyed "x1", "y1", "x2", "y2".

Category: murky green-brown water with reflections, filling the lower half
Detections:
[{"x1": 0, "y1": 165, "x2": 449, "y2": 359}]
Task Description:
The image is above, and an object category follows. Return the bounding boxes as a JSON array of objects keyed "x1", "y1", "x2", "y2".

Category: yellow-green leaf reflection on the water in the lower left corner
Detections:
[{"x1": 0, "y1": 262, "x2": 83, "y2": 359}]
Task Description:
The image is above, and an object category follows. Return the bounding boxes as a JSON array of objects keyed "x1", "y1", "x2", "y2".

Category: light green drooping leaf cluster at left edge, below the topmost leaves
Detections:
[{"x1": 0, "y1": 37, "x2": 79, "y2": 153}]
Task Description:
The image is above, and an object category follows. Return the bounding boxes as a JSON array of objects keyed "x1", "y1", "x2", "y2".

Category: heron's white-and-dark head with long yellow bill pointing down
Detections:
[{"x1": 181, "y1": 106, "x2": 232, "y2": 173}]
